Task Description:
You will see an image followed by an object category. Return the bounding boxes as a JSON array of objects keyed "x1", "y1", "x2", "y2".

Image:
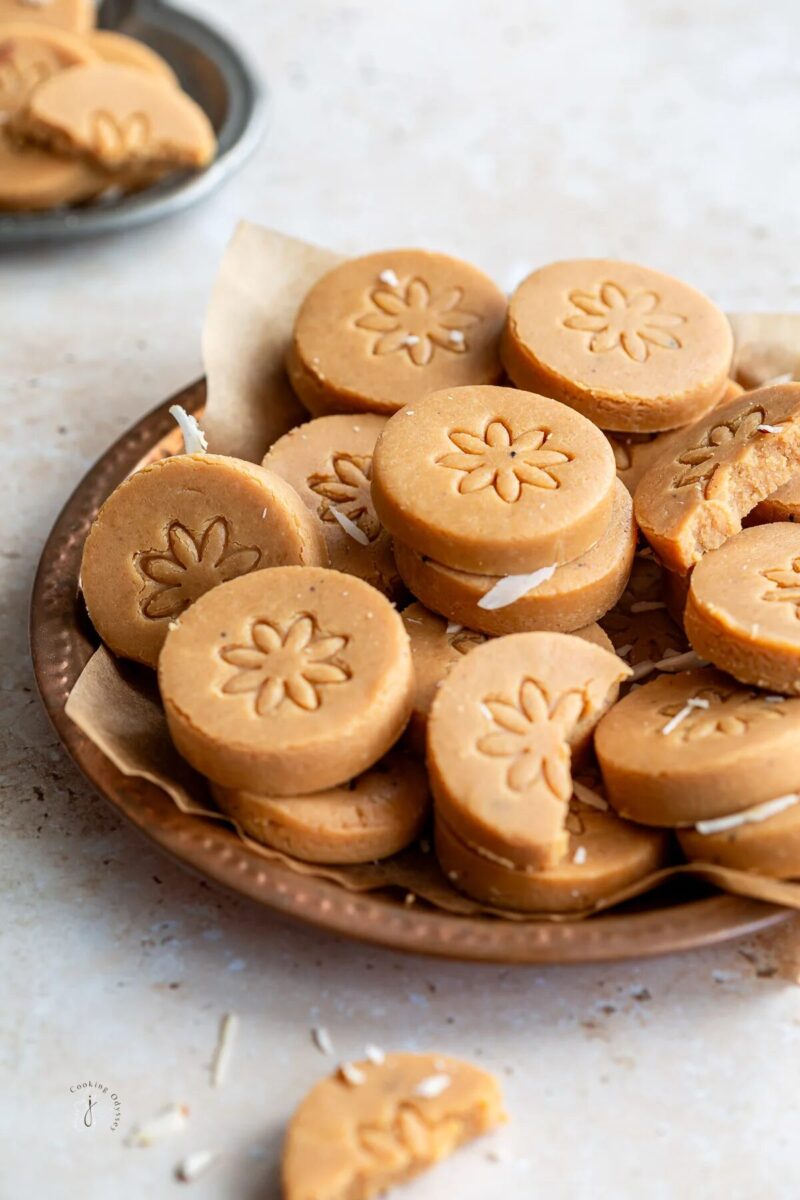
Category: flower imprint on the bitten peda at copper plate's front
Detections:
[{"x1": 477, "y1": 677, "x2": 587, "y2": 802}]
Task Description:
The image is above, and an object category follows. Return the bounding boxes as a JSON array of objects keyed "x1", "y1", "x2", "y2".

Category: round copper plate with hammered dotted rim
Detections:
[{"x1": 31, "y1": 382, "x2": 790, "y2": 962}]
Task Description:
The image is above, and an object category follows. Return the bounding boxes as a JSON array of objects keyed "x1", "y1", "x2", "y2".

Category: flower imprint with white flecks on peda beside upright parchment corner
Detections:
[{"x1": 355, "y1": 277, "x2": 481, "y2": 367}]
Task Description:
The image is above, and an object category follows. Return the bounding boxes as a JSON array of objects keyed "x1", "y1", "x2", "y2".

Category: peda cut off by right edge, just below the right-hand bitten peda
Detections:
[{"x1": 684, "y1": 522, "x2": 800, "y2": 694}]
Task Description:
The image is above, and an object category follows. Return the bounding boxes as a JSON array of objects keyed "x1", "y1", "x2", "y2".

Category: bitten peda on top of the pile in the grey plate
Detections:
[{"x1": 19, "y1": 62, "x2": 216, "y2": 169}]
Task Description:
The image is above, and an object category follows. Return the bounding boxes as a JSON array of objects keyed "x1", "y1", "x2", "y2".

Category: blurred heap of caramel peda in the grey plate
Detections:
[{"x1": 0, "y1": 0, "x2": 216, "y2": 211}]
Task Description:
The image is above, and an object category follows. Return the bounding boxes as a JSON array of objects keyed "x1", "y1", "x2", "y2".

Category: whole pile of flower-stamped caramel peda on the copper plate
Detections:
[{"x1": 82, "y1": 250, "x2": 800, "y2": 913}]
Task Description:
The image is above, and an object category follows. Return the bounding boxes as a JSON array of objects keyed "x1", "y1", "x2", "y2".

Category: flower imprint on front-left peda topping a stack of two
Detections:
[{"x1": 219, "y1": 614, "x2": 351, "y2": 716}]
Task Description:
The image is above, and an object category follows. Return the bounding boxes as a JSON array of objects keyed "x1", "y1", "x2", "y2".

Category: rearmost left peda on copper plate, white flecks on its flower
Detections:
[{"x1": 287, "y1": 250, "x2": 506, "y2": 416}]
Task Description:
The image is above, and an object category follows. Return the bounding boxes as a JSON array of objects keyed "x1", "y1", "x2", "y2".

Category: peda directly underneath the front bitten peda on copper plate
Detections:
[{"x1": 434, "y1": 797, "x2": 669, "y2": 913}]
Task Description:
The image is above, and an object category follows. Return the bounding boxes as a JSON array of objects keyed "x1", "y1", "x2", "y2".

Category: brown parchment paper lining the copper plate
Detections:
[{"x1": 66, "y1": 222, "x2": 800, "y2": 920}]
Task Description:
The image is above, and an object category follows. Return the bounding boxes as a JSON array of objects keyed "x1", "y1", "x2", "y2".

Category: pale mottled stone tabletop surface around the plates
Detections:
[{"x1": 0, "y1": 0, "x2": 800, "y2": 1200}]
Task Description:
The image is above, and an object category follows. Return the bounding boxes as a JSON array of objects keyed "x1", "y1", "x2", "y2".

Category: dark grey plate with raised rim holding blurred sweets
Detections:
[{"x1": 0, "y1": 0, "x2": 266, "y2": 245}]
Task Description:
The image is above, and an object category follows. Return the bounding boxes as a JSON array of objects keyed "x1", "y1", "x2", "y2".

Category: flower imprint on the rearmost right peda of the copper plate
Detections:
[{"x1": 564, "y1": 280, "x2": 686, "y2": 362}]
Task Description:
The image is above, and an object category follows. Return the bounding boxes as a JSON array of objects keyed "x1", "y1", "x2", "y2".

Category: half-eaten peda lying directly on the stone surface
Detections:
[{"x1": 282, "y1": 1054, "x2": 505, "y2": 1200}]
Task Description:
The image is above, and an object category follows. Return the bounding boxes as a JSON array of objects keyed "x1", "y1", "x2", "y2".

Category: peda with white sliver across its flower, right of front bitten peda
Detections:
[{"x1": 595, "y1": 667, "x2": 800, "y2": 827}]
